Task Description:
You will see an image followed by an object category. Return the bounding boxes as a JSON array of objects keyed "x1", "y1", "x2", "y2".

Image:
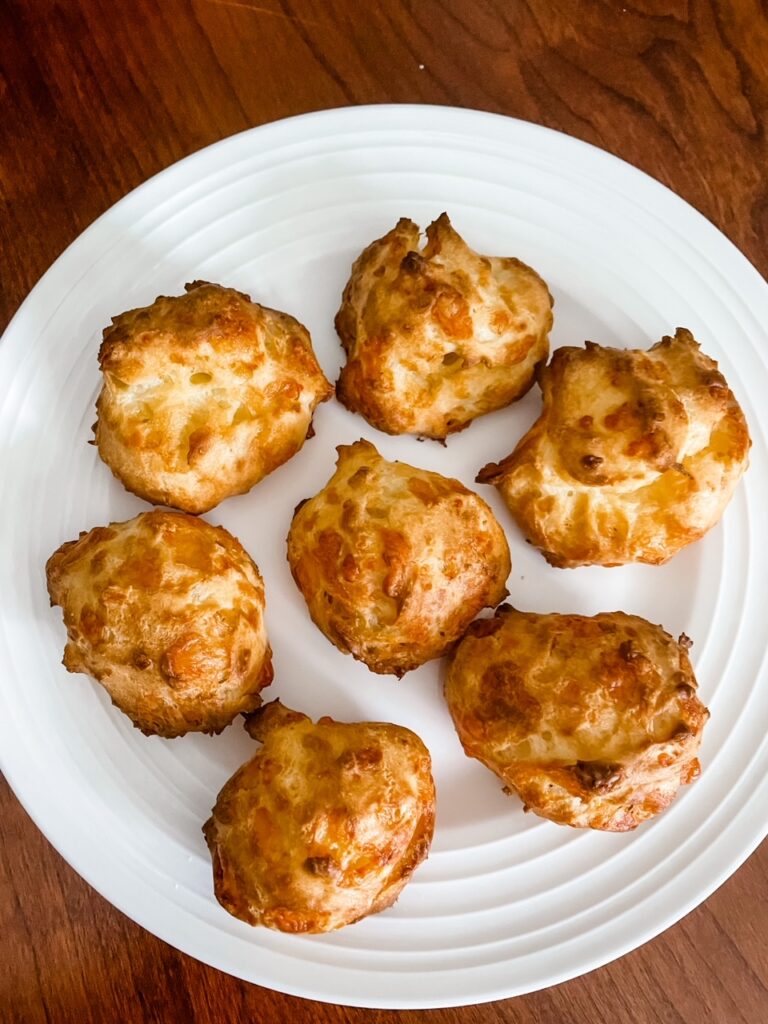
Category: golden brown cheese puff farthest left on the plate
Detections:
[{"x1": 46, "y1": 510, "x2": 272, "y2": 737}]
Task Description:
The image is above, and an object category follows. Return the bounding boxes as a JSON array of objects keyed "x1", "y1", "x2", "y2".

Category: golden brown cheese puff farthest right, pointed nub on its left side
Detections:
[{"x1": 477, "y1": 328, "x2": 751, "y2": 568}]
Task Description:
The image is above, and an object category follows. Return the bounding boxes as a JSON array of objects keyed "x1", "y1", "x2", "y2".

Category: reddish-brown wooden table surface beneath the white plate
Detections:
[{"x1": 0, "y1": 0, "x2": 768, "y2": 1024}]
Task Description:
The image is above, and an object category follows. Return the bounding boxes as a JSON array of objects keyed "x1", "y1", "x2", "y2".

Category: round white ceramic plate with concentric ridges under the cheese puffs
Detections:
[{"x1": 0, "y1": 106, "x2": 768, "y2": 1008}]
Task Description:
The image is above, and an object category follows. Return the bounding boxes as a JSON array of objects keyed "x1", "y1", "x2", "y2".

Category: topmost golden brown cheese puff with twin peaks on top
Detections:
[{"x1": 336, "y1": 213, "x2": 552, "y2": 439}]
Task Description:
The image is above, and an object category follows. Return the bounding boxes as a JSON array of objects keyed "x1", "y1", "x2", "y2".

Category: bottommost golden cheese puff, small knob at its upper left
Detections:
[{"x1": 203, "y1": 700, "x2": 435, "y2": 932}]
